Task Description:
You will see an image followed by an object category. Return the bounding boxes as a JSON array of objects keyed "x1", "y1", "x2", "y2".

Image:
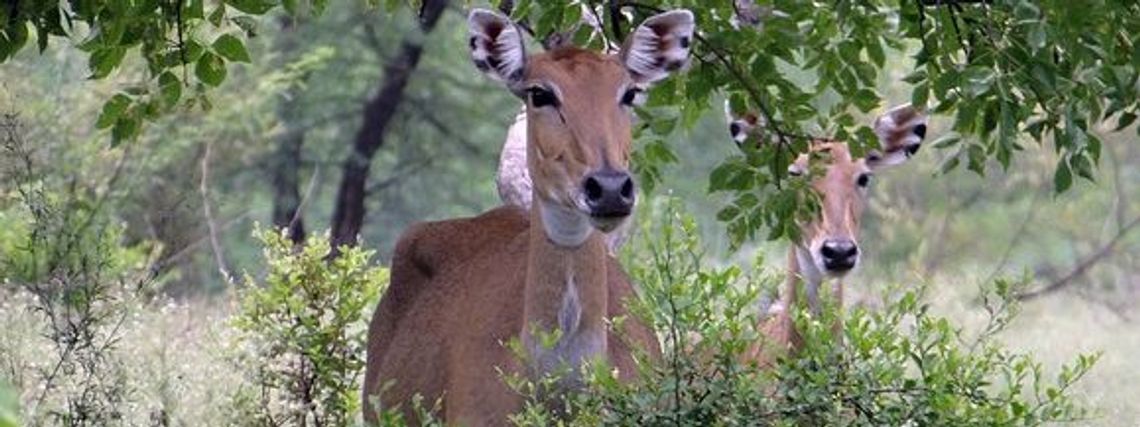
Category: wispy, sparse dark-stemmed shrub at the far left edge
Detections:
[{"x1": 0, "y1": 114, "x2": 154, "y2": 426}]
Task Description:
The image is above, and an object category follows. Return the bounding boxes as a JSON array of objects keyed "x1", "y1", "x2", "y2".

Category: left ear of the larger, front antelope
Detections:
[{"x1": 467, "y1": 9, "x2": 527, "y2": 91}]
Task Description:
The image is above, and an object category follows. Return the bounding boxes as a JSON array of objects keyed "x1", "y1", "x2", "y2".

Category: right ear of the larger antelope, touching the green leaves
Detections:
[{"x1": 620, "y1": 9, "x2": 695, "y2": 84}]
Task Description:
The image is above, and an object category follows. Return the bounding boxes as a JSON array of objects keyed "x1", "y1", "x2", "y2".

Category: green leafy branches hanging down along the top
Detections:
[{"x1": 0, "y1": 0, "x2": 1140, "y2": 244}]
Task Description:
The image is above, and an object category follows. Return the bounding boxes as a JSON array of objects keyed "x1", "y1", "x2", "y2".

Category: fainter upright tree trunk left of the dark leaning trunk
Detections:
[{"x1": 269, "y1": 17, "x2": 308, "y2": 244}]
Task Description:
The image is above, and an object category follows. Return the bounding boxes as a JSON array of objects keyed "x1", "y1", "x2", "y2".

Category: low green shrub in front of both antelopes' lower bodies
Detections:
[{"x1": 511, "y1": 202, "x2": 1097, "y2": 426}]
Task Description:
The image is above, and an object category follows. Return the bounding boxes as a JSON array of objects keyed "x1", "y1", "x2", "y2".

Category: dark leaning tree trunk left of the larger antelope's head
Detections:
[{"x1": 331, "y1": 0, "x2": 448, "y2": 256}]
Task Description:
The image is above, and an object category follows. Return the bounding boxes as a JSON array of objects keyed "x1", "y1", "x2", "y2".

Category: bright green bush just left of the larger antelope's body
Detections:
[{"x1": 234, "y1": 231, "x2": 388, "y2": 426}]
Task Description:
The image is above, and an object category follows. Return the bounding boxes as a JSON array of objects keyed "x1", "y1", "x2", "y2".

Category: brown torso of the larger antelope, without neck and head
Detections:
[{"x1": 365, "y1": 206, "x2": 657, "y2": 426}]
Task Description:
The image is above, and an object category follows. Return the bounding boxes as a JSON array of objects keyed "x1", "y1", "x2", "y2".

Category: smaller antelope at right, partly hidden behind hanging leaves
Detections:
[{"x1": 728, "y1": 105, "x2": 927, "y2": 364}]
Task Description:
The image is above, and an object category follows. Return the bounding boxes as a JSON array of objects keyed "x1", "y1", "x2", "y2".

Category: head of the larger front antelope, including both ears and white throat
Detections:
[{"x1": 469, "y1": 9, "x2": 693, "y2": 247}]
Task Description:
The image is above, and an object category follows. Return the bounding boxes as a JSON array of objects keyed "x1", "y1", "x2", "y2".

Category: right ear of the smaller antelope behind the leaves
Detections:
[{"x1": 866, "y1": 104, "x2": 927, "y2": 169}]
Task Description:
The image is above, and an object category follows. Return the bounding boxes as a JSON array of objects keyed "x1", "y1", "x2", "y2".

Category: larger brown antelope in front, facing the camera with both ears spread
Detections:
[{"x1": 364, "y1": 10, "x2": 693, "y2": 426}]
